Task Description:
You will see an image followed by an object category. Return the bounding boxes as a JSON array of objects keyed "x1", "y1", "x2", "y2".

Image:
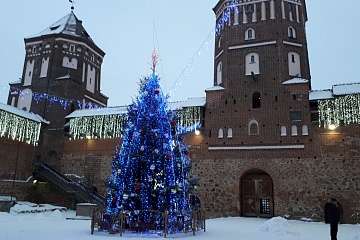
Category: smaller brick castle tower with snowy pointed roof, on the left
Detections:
[{"x1": 8, "y1": 11, "x2": 108, "y2": 166}]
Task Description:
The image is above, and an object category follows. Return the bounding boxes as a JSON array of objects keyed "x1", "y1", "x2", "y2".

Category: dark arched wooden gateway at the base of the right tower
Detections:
[{"x1": 240, "y1": 169, "x2": 274, "y2": 217}]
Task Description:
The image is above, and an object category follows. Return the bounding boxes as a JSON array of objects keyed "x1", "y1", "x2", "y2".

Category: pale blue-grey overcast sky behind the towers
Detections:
[{"x1": 0, "y1": 0, "x2": 360, "y2": 105}]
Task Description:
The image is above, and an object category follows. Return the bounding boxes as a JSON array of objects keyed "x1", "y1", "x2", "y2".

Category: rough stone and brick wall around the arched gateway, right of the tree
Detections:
[{"x1": 192, "y1": 126, "x2": 360, "y2": 222}]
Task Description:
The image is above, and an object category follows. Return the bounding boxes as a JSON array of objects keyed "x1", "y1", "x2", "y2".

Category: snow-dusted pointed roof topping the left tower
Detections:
[{"x1": 29, "y1": 12, "x2": 92, "y2": 41}]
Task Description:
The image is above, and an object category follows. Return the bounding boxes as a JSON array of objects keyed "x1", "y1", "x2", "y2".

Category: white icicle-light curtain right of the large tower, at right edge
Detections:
[{"x1": 318, "y1": 94, "x2": 360, "y2": 127}]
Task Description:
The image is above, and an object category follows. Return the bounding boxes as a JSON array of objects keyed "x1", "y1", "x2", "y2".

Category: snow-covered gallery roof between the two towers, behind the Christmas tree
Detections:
[{"x1": 66, "y1": 97, "x2": 206, "y2": 118}]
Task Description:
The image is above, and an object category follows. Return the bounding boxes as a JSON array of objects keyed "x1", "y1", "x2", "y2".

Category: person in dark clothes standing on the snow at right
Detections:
[{"x1": 325, "y1": 198, "x2": 341, "y2": 240}]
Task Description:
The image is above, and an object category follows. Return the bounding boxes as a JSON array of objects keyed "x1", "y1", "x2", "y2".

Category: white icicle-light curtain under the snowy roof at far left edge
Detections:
[{"x1": 0, "y1": 110, "x2": 41, "y2": 146}]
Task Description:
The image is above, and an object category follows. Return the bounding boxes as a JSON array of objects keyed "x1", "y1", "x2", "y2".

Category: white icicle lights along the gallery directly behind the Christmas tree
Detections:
[{"x1": 70, "y1": 107, "x2": 202, "y2": 140}]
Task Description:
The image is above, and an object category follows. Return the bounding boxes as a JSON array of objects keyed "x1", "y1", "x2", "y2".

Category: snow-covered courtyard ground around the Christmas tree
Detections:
[{"x1": 0, "y1": 203, "x2": 360, "y2": 240}]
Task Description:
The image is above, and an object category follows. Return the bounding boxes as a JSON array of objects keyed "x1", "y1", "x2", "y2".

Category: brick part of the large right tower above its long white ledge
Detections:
[{"x1": 205, "y1": 0, "x2": 311, "y2": 147}]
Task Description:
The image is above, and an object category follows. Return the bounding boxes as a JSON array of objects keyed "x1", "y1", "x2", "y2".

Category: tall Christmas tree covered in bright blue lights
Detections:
[{"x1": 105, "y1": 51, "x2": 191, "y2": 232}]
